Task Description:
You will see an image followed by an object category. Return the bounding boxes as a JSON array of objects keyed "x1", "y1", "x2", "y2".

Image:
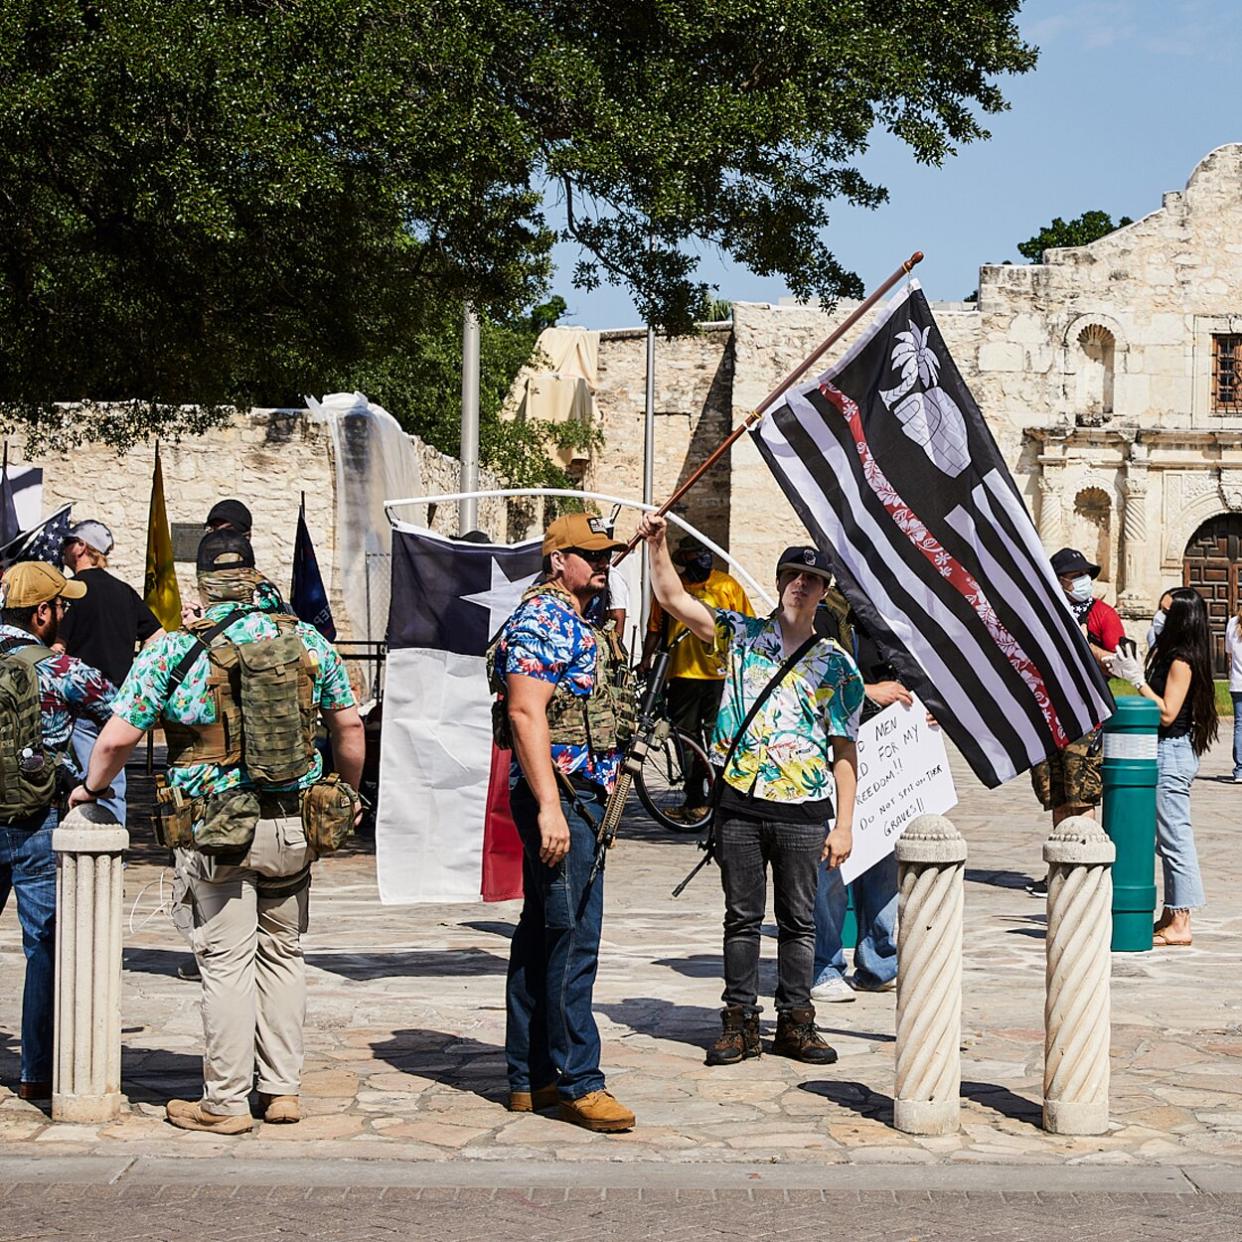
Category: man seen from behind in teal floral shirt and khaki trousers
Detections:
[{"x1": 70, "y1": 530, "x2": 364, "y2": 1134}]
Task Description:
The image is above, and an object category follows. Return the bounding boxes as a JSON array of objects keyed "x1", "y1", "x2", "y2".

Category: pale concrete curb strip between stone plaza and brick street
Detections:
[{"x1": 0, "y1": 1155, "x2": 1242, "y2": 1195}]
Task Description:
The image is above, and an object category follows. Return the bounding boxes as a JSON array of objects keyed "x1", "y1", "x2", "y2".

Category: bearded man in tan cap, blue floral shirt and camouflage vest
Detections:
[{"x1": 488, "y1": 513, "x2": 635, "y2": 1133}]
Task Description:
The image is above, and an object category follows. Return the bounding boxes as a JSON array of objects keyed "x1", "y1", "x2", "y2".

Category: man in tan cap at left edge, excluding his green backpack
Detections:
[{"x1": 0, "y1": 560, "x2": 116, "y2": 1099}]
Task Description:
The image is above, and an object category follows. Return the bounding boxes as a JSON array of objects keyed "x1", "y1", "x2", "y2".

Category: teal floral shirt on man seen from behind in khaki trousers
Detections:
[{"x1": 112, "y1": 602, "x2": 354, "y2": 797}]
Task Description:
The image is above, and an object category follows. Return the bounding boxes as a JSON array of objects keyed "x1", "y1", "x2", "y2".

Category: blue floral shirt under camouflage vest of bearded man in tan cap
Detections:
[{"x1": 496, "y1": 591, "x2": 621, "y2": 790}]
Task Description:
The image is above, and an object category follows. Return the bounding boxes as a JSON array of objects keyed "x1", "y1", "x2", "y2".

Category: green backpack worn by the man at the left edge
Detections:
[{"x1": 0, "y1": 638, "x2": 56, "y2": 823}]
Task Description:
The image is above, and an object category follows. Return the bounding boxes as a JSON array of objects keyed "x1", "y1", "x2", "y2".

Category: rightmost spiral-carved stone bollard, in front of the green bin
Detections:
[{"x1": 1043, "y1": 815, "x2": 1117, "y2": 1134}]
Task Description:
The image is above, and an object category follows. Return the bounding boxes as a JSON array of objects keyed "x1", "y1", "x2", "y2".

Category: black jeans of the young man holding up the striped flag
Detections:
[{"x1": 717, "y1": 816, "x2": 827, "y2": 1013}]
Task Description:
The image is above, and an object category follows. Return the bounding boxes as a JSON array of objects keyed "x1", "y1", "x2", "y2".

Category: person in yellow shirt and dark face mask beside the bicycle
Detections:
[{"x1": 640, "y1": 535, "x2": 755, "y2": 831}]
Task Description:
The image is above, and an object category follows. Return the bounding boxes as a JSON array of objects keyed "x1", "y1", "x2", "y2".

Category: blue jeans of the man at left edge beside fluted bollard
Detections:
[{"x1": 0, "y1": 807, "x2": 56, "y2": 1083}]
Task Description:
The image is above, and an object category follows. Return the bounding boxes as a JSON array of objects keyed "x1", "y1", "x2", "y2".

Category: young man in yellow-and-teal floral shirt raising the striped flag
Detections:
[{"x1": 638, "y1": 514, "x2": 863, "y2": 1066}]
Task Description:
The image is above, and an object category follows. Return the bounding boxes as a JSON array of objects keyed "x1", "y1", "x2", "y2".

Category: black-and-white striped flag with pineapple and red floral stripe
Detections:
[{"x1": 754, "y1": 281, "x2": 1113, "y2": 785}]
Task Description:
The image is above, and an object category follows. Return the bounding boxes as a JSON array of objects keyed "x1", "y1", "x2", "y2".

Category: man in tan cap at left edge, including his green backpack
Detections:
[{"x1": 0, "y1": 560, "x2": 114, "y2": 1099}]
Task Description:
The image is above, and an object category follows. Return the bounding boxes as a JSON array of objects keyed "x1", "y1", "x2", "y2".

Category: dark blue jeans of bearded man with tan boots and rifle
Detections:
[{"x1": 504, "y1": 781, "x2": 604, "y2": 1099}]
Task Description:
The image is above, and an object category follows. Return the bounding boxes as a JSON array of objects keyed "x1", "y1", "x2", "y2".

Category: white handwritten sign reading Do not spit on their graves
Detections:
[{"x1": 841, "y1": 698, "x2": 958, "y2": 884}]
